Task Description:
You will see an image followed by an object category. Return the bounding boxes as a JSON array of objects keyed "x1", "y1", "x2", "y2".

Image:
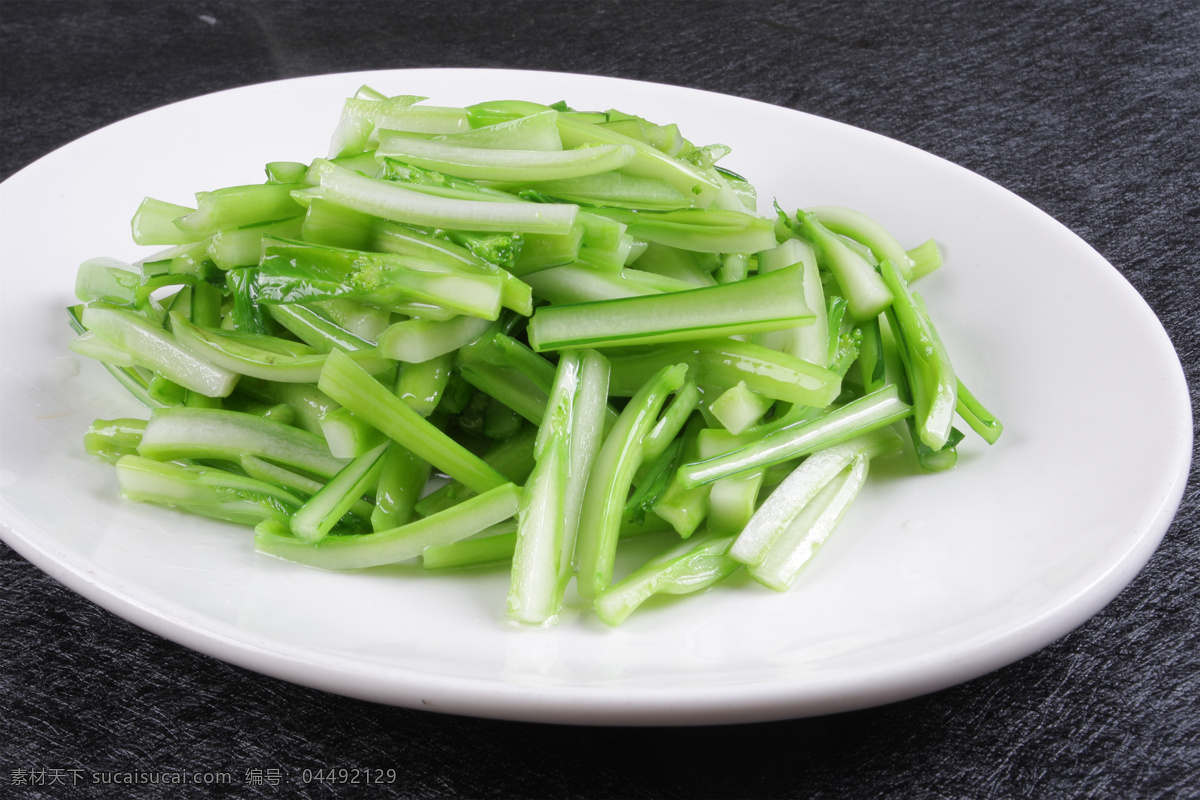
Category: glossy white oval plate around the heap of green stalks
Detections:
[{"x1": 0, "y1": 70, "x2": 1192, "y2": 724}]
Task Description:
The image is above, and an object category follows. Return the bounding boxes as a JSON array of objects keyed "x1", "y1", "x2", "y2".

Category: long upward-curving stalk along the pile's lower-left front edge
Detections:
[{"x1": 254, "y1": 483, "x2": 521, "y2": 570}]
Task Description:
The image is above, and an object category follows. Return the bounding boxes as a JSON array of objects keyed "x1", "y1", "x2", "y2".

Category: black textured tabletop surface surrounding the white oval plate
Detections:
[{"x1": 0, "y1": 0, "x2": 1200, "y2": 798}]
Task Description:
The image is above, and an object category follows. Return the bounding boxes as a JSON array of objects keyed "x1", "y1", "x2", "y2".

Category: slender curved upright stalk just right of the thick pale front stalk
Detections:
[{"x1": 576, "y1": 365, "x2": 688, "y2": 599}]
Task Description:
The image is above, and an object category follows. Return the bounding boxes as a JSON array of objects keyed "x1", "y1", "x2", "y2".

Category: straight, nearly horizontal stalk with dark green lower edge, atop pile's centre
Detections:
[{"x1": 529, "y1": 267, "x2": 814, "y2": 351}]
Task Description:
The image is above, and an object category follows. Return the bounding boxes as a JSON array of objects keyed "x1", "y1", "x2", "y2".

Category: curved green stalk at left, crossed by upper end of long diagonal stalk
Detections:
[{"x1": 170, "y1": 312, "x2": 391, "y2": 384}]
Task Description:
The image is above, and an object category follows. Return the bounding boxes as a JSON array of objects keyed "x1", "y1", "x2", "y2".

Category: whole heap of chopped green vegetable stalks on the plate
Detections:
[{"x1": 70, "y1": 88, "x2": 1001, "y2": 625}]
